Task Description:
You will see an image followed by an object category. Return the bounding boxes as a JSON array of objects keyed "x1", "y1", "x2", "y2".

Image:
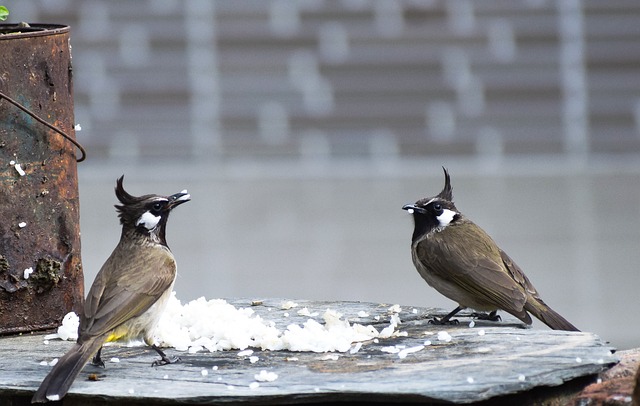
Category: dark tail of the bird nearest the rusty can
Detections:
[{"x1": 31, "y1": 338, "x2": 103, "y2": 403}]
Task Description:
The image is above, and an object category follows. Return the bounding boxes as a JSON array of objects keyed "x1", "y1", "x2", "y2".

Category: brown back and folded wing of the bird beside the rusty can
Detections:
[{"x1": 80, "y1": 244, "x2": 176, "y2": 336}]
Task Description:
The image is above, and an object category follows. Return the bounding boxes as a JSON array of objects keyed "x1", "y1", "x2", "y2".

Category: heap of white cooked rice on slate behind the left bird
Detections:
[{"x1": 45, "y1": 292, "x2": 400, "y2": 353}]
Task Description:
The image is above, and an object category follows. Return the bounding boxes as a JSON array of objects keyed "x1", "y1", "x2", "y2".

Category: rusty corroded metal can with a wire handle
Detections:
[{"x1": 0, "y1": 25, "x2": 84, "y2": 334}]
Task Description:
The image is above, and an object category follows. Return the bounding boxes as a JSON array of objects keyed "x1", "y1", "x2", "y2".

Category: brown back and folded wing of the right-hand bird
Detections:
[{"x1": 416, "y1": 221, "x2": 527, "y2": 318}]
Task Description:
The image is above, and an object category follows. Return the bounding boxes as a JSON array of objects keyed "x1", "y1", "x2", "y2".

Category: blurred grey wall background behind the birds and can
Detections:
[{"x1": 10, "y1": 0, "x2": 640, "y2": 349}]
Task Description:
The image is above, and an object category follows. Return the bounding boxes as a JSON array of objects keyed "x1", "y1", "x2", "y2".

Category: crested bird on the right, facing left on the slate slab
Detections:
[{"x1": 402, "y1": 167, "x2": 579, "y2": 331}]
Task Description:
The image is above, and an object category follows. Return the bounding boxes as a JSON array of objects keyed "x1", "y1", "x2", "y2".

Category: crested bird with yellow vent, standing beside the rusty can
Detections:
[{"x1": 31, "y1": 175, "x2": 191, "y2": 403}]
